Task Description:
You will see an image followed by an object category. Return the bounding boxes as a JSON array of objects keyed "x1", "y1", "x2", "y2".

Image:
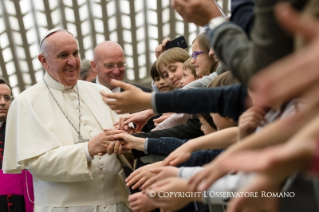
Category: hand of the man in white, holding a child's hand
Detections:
[{"x1": 88, "y1": 130, "x2": 123, "y2": 157}]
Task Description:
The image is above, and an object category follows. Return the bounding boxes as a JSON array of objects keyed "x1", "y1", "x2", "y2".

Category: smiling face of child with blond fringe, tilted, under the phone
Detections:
[{"x1": 160, "y1": 62, "x2": 183, "y2": 89}]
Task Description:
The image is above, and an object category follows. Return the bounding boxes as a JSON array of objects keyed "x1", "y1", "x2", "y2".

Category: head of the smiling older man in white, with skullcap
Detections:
[{"x1": 38, "y1": 31, "x2": 80, "y2": 87}]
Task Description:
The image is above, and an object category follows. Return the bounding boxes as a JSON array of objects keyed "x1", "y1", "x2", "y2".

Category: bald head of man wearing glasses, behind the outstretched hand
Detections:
[{"x1": 91, "y1": 41, "x2": 125, "y2": 90}]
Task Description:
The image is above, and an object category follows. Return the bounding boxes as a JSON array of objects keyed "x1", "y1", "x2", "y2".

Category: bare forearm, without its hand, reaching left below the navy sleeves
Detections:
[{"x1": 184, "y1": 127, "x2": 238, "y2": 152}]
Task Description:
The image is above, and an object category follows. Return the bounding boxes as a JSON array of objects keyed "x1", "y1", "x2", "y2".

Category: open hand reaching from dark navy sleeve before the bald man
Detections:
[{"x1": 101, "y1": 80, "x2": 152, "y2": 114}]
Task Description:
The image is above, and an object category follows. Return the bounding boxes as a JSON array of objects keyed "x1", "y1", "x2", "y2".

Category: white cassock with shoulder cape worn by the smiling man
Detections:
[{"x1": 3, "y1": 74, "x2": 134, "y2": 212}]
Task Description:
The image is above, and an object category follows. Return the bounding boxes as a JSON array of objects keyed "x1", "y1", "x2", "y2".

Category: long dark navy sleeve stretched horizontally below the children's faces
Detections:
[{"x1": 152, "y1": 84, "x2": 248, "y2": 121}]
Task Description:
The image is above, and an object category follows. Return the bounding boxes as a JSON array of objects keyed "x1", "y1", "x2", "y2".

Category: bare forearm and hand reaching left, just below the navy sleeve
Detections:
[{"x1": 163, "y1": 127, "x2": 238, "y2": 166}]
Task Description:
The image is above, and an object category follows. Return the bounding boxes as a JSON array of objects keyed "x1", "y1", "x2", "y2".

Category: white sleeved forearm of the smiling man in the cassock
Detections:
[{"x1": 23, "y1": 143, "x2": 92, "y2": 182}]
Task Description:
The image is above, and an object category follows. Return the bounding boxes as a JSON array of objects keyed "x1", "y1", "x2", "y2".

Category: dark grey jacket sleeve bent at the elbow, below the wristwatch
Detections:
[{"x1": 210, "y1": 0, "x2": 293, "y2": 85}]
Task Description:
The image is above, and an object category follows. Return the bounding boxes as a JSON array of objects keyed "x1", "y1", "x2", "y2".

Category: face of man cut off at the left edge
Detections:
[{"x1": 0, "y1": 84, "x2": 11, "y2": 122}]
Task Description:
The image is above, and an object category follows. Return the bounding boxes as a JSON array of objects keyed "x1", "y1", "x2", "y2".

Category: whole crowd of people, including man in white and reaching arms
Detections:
[{"x1": 0, "y1": 0, "x2": 319, "y2": 212}]
